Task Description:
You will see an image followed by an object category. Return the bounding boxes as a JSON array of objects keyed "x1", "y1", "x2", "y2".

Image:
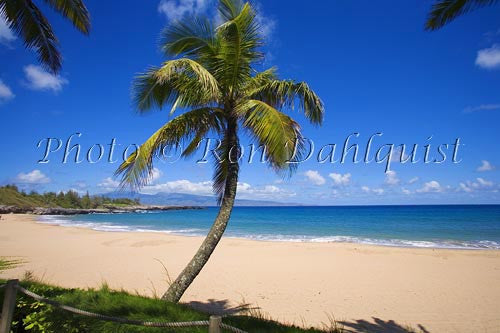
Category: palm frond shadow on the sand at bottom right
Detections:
[{"x1": 339, "y1": 317, "x2": 430, "y2": 333}]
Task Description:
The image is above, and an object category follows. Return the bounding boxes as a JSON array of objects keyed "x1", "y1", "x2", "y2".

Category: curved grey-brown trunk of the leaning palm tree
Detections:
[{"x1": 162, "y1": 124, "x2": 239, "y2": 303}]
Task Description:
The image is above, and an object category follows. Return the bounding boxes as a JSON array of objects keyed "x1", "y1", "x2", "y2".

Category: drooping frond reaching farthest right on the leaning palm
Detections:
[{"x1": 250, "y1": 80, "x2": 324, "y2": 125}]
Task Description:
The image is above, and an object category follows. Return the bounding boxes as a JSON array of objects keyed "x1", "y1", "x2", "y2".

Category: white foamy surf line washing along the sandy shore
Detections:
[{"x1": 38, "y1": 215, "x2": 500, "y2": 249}]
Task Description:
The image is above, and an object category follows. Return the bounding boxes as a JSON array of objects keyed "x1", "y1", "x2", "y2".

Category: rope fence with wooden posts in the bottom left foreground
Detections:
[{"x1": 0, "y1": 280, "x2": 247, "y2": 333}]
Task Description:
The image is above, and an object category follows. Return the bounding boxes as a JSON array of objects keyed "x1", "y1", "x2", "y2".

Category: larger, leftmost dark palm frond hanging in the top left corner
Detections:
[{"x1": 0, "y1": 0, "x2": 61, "y2": 73}]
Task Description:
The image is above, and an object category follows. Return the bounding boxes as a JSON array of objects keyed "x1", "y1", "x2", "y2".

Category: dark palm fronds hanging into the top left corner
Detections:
[{"x1": 0, "y1": 0, "x2": 90, "y2": 73}]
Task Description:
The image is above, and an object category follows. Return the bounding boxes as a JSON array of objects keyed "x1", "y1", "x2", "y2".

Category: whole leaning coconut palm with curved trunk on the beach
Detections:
[{"x1": 116, "y1": 0, "x2": 324, "y2": 302}]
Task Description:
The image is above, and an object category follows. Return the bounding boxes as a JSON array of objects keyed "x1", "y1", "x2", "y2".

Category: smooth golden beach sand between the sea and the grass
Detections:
[{"x1": 0, "y1": 215, "x2": 500, "y2": 333}]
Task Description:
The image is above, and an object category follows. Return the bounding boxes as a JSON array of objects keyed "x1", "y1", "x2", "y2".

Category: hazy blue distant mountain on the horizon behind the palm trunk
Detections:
[{"x1": 104, "y1": 192, "x2": 297, "y2": 206}]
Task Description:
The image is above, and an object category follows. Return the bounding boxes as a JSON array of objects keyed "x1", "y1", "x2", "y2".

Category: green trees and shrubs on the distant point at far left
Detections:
[{"x1": 0, "y1": 185, "x2": 140, "y2": 209}]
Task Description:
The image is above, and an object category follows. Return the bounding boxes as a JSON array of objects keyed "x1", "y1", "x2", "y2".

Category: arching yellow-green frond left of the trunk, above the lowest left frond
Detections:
[{"x1": 133, "y1": 58, "x2": 220, "y2": 112}]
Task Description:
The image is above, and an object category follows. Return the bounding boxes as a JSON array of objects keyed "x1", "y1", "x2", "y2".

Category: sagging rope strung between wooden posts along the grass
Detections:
[{"x1": 15, "y1": 284, "x2": 247, "y2": 333}]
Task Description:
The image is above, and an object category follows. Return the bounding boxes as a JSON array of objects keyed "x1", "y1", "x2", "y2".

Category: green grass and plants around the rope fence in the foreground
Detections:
[{"x1": 0, "y1": 280, "x2": 342, "y2": 333}]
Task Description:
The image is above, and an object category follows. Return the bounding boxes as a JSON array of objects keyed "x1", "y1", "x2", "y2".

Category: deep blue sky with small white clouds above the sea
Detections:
[{"x1": 0, "y1": 0, "x2": 500, "y2": 205}]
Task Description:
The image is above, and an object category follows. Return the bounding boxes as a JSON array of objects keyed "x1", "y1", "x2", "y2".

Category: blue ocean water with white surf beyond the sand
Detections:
[{"x1": 37, "y1": 205, "x2": 500, "y2": 249}]
